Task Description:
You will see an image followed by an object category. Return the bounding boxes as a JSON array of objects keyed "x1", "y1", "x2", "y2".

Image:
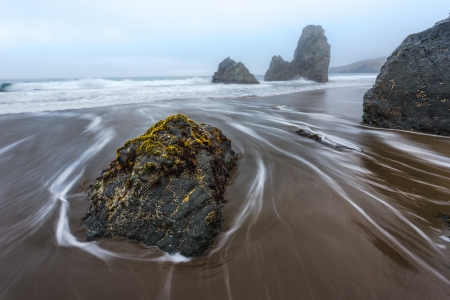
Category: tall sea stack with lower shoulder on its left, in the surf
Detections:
[{"x1": 264, "y1": 25, "x2": 331, "y2": 82}]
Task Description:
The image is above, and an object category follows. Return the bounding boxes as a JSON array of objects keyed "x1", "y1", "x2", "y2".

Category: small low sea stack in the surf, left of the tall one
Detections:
[{"x1": 212, "y1": 57, "x2": 259, "y2": 84}]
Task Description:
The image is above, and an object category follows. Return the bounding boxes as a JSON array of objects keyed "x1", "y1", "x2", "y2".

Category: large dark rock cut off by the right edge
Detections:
[{"x1": 363, "y1": 18, "x2": 450, "y2": 135}]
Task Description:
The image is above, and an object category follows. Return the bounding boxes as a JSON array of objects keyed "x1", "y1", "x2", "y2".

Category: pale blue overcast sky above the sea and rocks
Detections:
[{"x1": 0, "y1": 0, "x2": 450, "y2": 79}]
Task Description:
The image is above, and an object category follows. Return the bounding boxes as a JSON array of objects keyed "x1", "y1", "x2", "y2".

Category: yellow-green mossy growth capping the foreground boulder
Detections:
[{"x1": 111, "y1": 114, "x2": 227, "y2": 180}]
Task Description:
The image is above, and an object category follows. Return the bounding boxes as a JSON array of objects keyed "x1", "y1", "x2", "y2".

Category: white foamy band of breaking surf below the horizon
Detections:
[{"x1": 0, "y1": 74, "x2": 375, "y2": 114}]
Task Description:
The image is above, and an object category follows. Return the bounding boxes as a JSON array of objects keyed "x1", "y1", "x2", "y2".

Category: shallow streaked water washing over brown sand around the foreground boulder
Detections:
[{"x1": 0, "y1": 84, "x2": 450, "y2": 299}]
